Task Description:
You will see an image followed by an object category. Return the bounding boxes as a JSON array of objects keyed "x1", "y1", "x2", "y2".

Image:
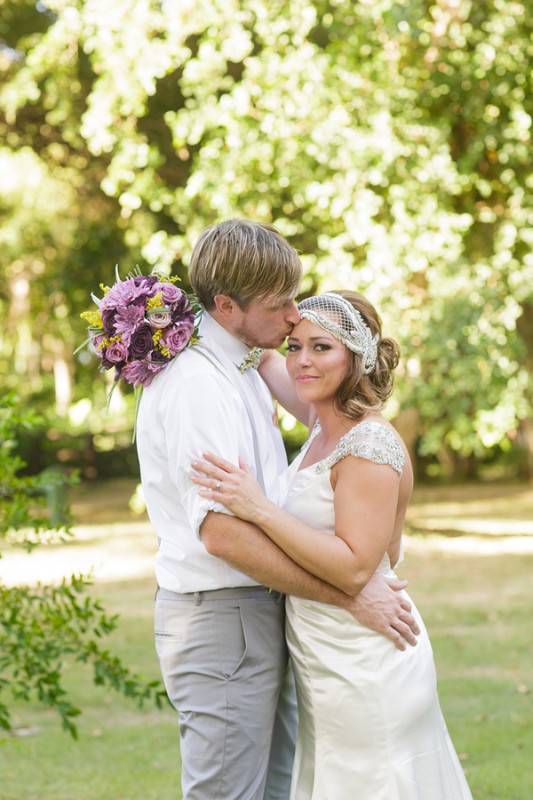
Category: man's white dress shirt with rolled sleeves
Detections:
[{"x1": 137, "y1": 313, "x2": 287, "y2": 592}]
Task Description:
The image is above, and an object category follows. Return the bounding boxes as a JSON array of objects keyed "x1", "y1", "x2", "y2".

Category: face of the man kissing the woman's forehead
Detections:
[{"x1": 235, "y1": 295, "x2": 300, "y2": 348}]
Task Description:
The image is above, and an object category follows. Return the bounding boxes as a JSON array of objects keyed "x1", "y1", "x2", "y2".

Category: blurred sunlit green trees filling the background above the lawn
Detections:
[{"x1": 0, "y1": 0, "x2": 533, "y2": 479}]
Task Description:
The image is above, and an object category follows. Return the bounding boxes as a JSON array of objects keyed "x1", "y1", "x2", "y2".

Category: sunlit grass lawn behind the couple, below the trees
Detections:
[{"x1": 0, "y1": 482, "x2": 533, "y2": 800}]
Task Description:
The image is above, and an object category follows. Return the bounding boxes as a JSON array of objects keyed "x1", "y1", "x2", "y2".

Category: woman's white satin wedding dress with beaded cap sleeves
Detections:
[{"x1": 284, "y1": 420, "x2": 472, "y2": 800}]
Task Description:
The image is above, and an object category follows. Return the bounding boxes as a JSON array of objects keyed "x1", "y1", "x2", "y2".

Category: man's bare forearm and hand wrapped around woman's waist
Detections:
[{"x1": 200, "y1": 511, "x2": 419, "y2": 650}]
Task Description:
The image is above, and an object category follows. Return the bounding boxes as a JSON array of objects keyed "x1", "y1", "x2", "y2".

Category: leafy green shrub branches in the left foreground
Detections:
[{"x1": 0, "y1": 395, "x2": 163, "y2": 736}]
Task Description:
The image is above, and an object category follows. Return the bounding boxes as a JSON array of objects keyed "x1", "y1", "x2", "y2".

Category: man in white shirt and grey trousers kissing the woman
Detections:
[{"x1": 137, "y1": 220, "x2": 416, "y2": 800}]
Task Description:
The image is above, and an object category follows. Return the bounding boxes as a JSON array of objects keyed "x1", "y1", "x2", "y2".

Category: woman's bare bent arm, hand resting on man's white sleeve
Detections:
[{"x1": 191, "y1": 455, "x2": 400, "y2": 596}]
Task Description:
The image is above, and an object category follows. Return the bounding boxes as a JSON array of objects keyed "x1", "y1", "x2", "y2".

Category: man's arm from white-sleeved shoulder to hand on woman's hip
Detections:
[{"x1": 161, "y1": 360, "x2": 415, "y2": 649}]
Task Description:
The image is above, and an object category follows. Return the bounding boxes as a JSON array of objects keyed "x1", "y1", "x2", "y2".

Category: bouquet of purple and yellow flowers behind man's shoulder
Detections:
[{"x1": 76, "y1": 267, "x2": 201, "y2": 432}]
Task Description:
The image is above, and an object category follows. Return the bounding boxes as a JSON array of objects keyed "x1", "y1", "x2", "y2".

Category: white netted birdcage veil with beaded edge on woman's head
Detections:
[{"x1": 298, "y1": 292, "x2": 379, "y2": 375}]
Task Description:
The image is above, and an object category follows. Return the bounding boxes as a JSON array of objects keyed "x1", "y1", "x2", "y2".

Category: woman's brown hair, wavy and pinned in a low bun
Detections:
[{"x1": 335, "y1": 290, "x2": 400, "y2": 420}]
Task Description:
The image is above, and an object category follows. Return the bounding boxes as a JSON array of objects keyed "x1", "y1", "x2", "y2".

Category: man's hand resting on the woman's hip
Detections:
[{"x1": 350, "y1": 574, "x2": 420, "y2": 650}]
